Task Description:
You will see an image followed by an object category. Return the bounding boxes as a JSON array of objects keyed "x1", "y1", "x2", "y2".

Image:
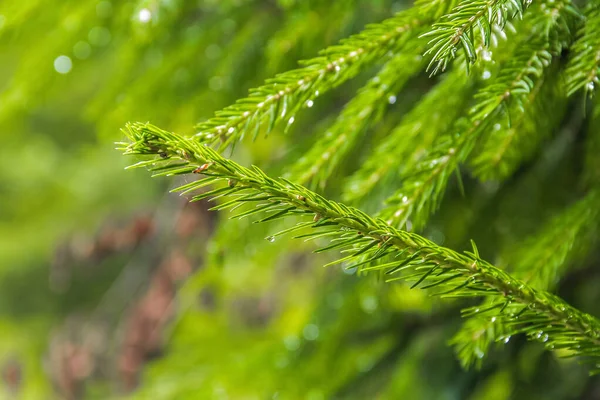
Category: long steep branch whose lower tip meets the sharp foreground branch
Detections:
[{"x1": 381, "y1": 37, "x2": 551, "y2": 229}]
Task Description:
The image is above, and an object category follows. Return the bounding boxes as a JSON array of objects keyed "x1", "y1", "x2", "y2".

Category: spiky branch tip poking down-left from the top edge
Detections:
[{"x1": 422, "y1": 0, "x2": 531, "y2": 74}]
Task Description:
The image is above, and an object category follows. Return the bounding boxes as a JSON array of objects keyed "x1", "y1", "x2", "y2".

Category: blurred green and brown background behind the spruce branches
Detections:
[{"x1": 0, "y1": 0, "x2": 600, "y2": 400}]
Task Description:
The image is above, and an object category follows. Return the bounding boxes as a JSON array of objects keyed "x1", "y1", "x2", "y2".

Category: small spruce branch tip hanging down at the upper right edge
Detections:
[{"x1": 565, "y1": 2, "x2": 600, "y2": 95}]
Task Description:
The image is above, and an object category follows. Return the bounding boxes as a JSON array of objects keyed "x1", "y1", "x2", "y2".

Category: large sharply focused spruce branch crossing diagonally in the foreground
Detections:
[{"x1": 121, "y1": 124, "x2": 600, "y2": 372}]
